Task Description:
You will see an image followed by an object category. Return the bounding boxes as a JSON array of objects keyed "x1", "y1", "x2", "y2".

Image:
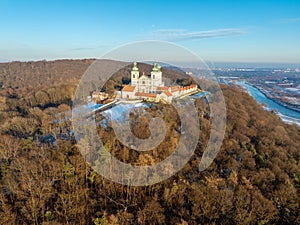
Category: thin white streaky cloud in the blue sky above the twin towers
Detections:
[{"x1": 151, "y1": 29, "x2": 246, "y2": 41}]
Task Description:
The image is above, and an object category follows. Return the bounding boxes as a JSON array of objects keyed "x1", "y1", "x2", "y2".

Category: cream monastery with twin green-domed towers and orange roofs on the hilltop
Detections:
[{"x1": 121, "y1": 62, "x2": 198, "y2": 103}]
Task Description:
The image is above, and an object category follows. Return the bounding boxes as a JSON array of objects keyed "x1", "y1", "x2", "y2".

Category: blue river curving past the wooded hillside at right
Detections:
[{"x1": 237, "y1": 81, "x2": 300, "y2": 126}]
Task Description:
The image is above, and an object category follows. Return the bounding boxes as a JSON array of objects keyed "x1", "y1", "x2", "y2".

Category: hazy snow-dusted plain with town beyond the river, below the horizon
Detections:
[{"x1": 213, "y1": 68, "x2": 300, "y2": 112}]
